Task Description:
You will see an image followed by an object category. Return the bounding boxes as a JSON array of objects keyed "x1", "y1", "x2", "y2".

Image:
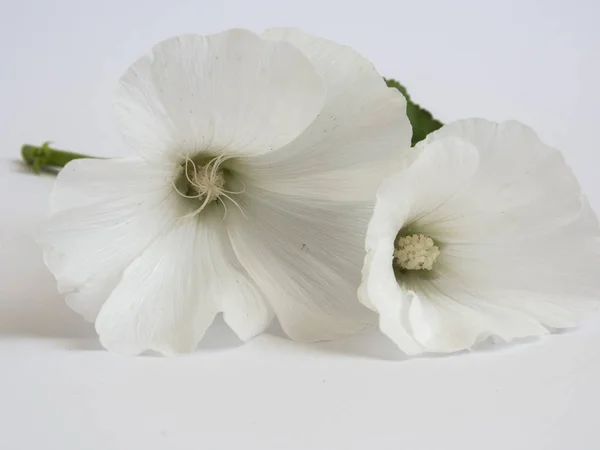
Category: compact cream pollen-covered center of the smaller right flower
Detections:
[{"x1": 394, "y1": 234, "x2": 440, "y2": 270}]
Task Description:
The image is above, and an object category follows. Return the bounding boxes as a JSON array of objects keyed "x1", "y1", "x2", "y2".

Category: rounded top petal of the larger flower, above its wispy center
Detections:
[{"x1": 116, "y1": 30, "x2": 325, "y2": 162}]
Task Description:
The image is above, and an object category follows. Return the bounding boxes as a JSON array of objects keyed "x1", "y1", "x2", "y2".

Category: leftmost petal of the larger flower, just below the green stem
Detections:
[{"x1": 37, "y1": 159, "x2": 178, "y2": 296}]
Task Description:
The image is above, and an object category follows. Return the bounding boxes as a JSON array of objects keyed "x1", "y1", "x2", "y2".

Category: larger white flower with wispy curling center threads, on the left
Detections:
[{"x1": 39, "y1": 29, "x2": 411, "y2": 354}]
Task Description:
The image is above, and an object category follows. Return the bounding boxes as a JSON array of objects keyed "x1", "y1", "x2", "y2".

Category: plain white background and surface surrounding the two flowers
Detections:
[{"x1": 0, "y1": 0, "x2": 600, "y2": 450}]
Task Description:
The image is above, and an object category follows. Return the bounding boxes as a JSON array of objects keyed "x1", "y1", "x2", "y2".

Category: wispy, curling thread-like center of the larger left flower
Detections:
[{"x1": 173, "y1": 155, "x2": 243, "y2": 217}]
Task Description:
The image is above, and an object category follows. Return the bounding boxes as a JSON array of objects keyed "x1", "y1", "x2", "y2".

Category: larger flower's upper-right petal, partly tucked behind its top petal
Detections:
[{"x1": 241, "y1": 29, "x2": 412, "y2": 201}]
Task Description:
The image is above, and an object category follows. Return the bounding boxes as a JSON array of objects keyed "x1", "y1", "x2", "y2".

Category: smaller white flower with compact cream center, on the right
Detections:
[{"x1": 359, "y1": 120, "x2": 600, "y2": 354}]
